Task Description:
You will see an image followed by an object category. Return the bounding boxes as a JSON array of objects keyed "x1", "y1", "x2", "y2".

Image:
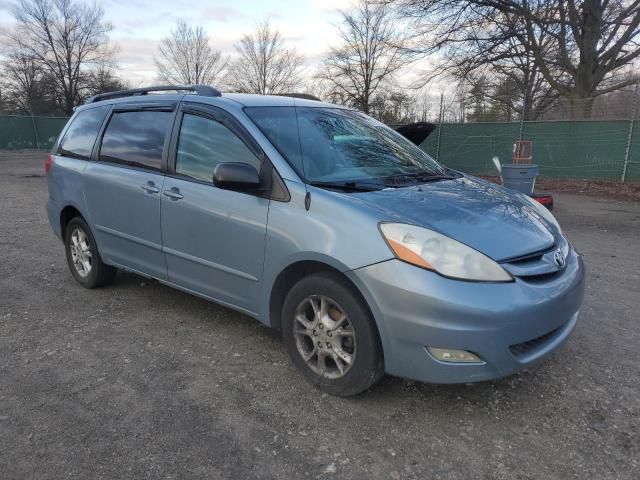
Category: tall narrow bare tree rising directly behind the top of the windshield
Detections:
[{"x1": 320, "y1": 0, "x2": 407, "y2": 113}]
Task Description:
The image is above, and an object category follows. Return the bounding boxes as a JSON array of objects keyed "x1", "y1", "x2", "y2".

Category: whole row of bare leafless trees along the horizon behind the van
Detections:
[{"x1": 0, "y1": 0, "x2": 640, "y2": 123}]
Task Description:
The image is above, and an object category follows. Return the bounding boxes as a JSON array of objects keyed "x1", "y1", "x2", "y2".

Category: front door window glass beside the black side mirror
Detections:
[{"x1": 176, "y1": 113, "x2": 260, "y2": 182}]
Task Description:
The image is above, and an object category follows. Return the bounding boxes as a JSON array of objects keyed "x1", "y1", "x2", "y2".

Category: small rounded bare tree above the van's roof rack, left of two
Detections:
[{"x1": 154, "y1": 21, "x2": 229, "y2": 85}]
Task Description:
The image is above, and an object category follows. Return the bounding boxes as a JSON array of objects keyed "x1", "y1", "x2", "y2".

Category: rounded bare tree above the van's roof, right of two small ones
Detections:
[{"x1": 228, "y1": 21, "x2": 304, "y2": 95}]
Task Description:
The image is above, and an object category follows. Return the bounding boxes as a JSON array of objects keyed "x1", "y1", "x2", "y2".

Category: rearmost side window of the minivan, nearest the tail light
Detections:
[{"x1": 58, "y1": 105, "x2": 109, "y2": 159}]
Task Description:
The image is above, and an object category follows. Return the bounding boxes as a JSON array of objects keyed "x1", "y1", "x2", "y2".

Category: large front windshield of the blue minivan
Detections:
[{"x1": 245, "y1": 107, "x2": 448, "y2": 185}]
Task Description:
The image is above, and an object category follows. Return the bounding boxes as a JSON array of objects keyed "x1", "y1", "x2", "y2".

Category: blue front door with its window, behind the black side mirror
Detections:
[{"x1": 161, "y1": 103, "x2": 271, "y2": 313}]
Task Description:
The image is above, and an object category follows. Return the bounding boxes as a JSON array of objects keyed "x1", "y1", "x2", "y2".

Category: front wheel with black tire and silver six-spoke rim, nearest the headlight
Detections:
[{"x1": 282, "y1": 272, "x2": 384, "y2": 397}]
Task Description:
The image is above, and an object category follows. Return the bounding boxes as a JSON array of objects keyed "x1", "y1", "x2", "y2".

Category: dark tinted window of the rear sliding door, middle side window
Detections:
[{"x1": 100, "y1": 112, "x2": 172, "y2": 170}]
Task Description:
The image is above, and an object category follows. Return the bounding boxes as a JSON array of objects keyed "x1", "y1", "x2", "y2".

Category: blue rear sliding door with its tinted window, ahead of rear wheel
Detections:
[{"x1": 85, "y1": 103, "x2": 176, "y2": 279}]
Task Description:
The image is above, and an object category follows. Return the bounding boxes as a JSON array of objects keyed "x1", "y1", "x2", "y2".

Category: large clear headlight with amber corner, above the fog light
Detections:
[{"x1": 380, "y1": 223, "x2": 513, "y2": 282}]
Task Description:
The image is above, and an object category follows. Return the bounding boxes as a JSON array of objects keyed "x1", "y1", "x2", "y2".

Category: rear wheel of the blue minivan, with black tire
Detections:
[{"x1": 64, "y1": 217, "x2": 118, "y2": 288}]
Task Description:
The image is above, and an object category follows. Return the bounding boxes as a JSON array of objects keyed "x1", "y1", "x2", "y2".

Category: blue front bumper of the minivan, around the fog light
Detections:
[{"x1": 349, "y1": 249, "x2": 585, "y2": 383}]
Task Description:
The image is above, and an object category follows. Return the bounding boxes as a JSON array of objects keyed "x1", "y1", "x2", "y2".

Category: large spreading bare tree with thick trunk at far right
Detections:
[{"x1": 393, "y1": 0, "x2": 640, "y2": 117}]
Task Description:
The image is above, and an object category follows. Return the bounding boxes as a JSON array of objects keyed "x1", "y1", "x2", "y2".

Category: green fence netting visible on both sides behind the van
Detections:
[{"x1": 0, "y1": 116, "x2": 640, "y2": 181}]
